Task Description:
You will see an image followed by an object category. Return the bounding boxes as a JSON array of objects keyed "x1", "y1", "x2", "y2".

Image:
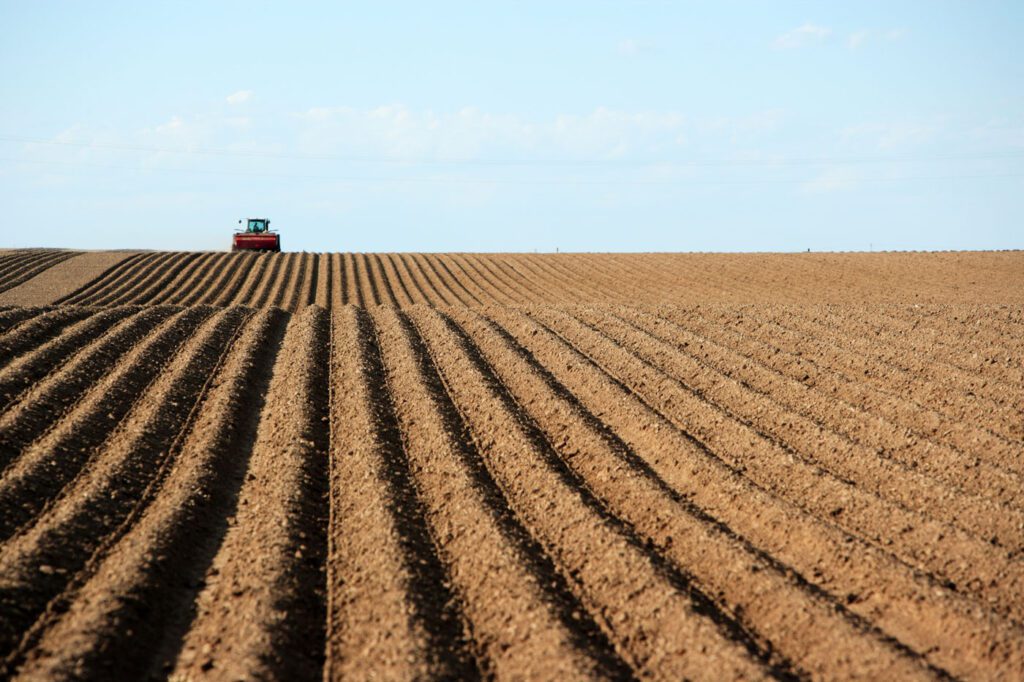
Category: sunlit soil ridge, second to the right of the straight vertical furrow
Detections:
[{"x1": 374, "y1": 307, "x2": 611, "y2": 678}]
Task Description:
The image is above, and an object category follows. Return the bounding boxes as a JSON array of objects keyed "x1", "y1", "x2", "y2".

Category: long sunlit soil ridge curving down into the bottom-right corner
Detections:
[{"x1": 487, "y1": 308, "x2": 1024, "y2": 677}]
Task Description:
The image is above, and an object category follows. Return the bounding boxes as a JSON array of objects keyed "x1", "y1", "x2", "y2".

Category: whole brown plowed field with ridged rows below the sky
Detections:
[{"x1": 0, "y1": 246, "x2": 1024, "y2": 680}]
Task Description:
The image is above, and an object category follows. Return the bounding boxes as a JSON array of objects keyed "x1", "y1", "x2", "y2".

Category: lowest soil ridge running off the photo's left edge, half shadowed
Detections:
[{"x1": 0, "y1": 308, "x2": 247, "y2": 657}]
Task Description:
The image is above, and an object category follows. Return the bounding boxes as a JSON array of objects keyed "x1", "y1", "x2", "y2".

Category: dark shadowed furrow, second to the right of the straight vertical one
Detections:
[{"x1": 396, "y1": 310, "x2": 634, "y2": 679}]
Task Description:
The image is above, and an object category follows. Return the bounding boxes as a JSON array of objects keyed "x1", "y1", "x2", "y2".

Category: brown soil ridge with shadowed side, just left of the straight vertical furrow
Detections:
[{"x1": 171, "y1": 307, "x2": 330, "y2": 680}]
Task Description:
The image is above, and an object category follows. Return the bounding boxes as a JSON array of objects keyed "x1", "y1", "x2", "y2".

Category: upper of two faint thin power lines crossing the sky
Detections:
[{"x1": 0, "y1": 135, "x2": 1024, "y2": 167}]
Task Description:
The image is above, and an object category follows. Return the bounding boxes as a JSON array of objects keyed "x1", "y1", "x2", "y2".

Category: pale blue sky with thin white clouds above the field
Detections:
[{"x1": 0, "y1": 0, "x2": 1024, "y2": 252}]
